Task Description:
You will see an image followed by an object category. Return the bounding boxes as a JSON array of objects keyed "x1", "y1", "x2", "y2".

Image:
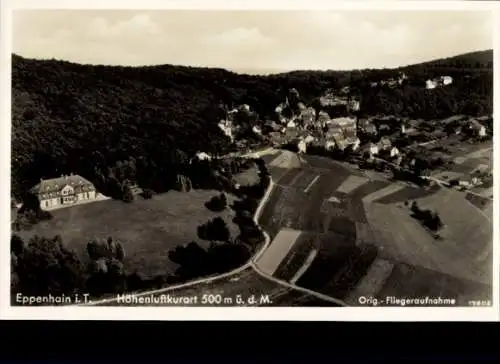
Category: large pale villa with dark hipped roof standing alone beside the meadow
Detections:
[{"x1": 30, "y1": 174, "x2": 97, "y2": 210}]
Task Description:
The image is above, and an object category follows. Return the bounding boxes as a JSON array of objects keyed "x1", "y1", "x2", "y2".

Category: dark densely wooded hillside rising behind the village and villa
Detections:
[{"x1": 12, "y1": 51, "x2": 493, "y2": 198}]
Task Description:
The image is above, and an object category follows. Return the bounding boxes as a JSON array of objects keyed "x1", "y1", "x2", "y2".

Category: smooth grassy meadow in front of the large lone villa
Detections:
[{"x1": 19, "y1": 190, "x2": 239, "y2": 277}]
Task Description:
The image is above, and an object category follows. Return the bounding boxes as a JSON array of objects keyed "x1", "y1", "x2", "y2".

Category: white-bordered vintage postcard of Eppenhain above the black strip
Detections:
[{"x1": 0, "y1": 1, "x2": 498, "y2": 320}]
